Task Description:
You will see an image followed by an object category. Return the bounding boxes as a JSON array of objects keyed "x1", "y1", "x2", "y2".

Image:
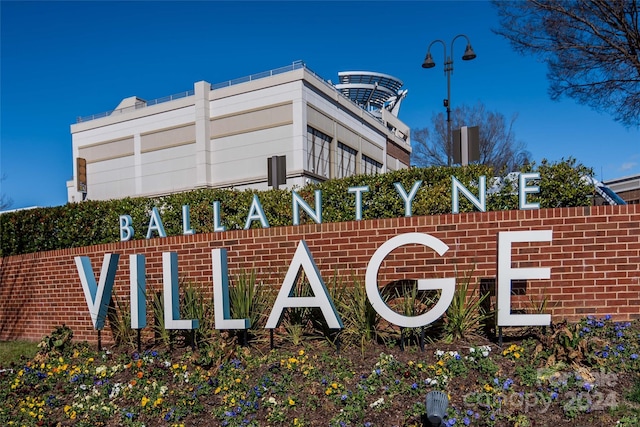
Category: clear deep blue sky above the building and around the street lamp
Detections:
[{"x1": 0, "y1": 1, "x2": 640, "y2": 208}]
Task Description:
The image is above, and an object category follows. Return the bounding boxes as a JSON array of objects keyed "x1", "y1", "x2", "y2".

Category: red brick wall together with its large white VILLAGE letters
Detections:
[{"x1": 0, "y1": 205, "x2": 640, "y2": 341}]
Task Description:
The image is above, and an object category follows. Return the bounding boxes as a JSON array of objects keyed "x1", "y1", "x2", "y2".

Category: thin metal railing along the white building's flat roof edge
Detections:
[{"x1": 76, "y1": 61, "x2": 380, "y2": 123}]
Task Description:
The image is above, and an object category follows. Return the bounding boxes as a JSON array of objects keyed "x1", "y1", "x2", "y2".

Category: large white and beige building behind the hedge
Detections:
[{"x1": 67, "y1": 62, "x2": 411, "y2": 202}]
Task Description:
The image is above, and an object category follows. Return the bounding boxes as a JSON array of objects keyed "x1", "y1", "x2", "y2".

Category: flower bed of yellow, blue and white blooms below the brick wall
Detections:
[{"x1": 0, "y1": 317, "x2": 640, "y2": 427}]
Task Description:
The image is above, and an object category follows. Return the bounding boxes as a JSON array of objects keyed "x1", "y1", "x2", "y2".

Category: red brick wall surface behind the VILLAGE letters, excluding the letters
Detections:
[{"x1": 0, "y1": 205, "x2": 640, "y2": 342}]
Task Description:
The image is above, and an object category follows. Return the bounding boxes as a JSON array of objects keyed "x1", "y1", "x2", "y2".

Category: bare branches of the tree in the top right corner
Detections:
[{"x1": 493, "y1": 0, "x2": 640, "y2": 127}]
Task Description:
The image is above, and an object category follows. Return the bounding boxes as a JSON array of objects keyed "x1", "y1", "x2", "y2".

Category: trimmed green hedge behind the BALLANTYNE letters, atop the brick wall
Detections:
[{"x1": 0, "y1": 159, "x2": 592, "y2": 257}]
